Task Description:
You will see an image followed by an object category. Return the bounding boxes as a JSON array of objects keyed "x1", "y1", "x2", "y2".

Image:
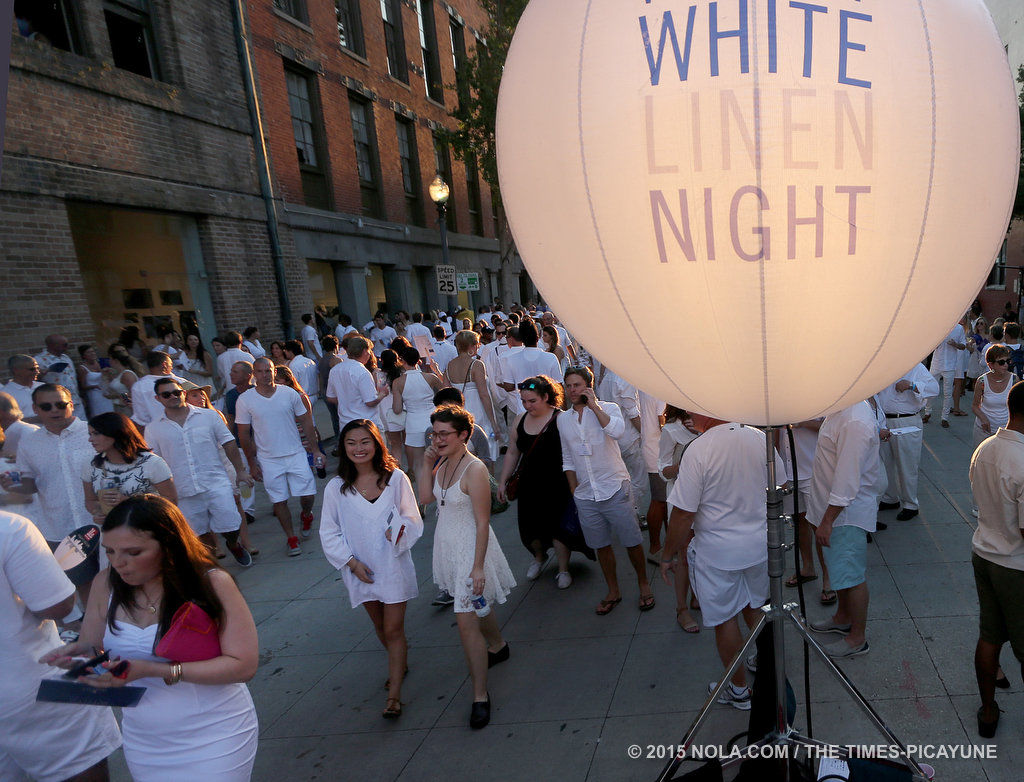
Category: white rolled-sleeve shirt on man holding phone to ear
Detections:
[{"x1": 557, "y1": 399, "x2": 630, "y2": 503}]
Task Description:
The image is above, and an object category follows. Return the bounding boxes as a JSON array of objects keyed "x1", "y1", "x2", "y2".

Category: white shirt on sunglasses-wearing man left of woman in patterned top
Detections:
[{"x1": 15, "y1": 419, "x2": 96, "y2": 540}]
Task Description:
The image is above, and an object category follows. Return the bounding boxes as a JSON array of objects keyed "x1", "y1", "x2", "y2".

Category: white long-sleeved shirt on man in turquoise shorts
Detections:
[{"x1": 807, "y1": 401, "x2": 882, "y2": 532}]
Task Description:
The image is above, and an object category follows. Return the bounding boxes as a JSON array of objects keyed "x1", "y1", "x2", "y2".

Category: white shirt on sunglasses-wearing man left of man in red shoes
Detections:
[{"x1": 145, "y1": 404, "x2": 234, "y2": 496}]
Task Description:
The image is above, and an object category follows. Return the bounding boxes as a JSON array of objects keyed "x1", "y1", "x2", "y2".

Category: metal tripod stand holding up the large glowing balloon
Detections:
[{"x1": 657, "y1": 427, "x2": 928, "y2": 782}]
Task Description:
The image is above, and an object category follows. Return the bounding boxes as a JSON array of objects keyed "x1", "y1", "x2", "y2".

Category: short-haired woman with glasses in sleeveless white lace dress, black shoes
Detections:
[{"x1": 416, "y1": 404, "x2": 515, "y2": 728}]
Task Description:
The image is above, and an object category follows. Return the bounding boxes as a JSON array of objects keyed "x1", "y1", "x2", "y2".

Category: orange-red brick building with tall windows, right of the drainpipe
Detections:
[{"x1": 248, "y1": 0, "x2": 531, "y2": 323}]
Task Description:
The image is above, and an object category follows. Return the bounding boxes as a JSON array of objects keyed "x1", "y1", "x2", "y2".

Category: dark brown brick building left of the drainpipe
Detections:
[{"x1": 0, "y1": 0, "x2": 309, "y2": 360}]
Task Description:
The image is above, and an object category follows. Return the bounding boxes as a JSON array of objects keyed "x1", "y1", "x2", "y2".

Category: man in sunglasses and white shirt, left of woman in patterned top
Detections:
[{"x1": 0, "y1": 383, "x2": 96, "y2": 547}]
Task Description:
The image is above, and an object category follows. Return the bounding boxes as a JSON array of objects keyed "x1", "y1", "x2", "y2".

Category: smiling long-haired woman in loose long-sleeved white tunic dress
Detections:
[{"x1": 321, "y1": 419, "x2": 423, "y2": 720}]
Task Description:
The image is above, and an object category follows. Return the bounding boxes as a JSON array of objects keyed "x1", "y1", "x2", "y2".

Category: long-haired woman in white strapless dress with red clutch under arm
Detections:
[{"x1": 41, "y1": 494, "x2": 259, "y2": 782}]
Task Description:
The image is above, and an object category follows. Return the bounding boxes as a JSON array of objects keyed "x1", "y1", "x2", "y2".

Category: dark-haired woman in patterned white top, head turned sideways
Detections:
[{"x1": 82, "y1": 412, "x2": 178, "y2": 523}]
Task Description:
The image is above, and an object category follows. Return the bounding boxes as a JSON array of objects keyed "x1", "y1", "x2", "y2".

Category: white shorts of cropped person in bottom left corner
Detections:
[{"x1": 0, "y1": 687, "x2": 121, "y2": 782}]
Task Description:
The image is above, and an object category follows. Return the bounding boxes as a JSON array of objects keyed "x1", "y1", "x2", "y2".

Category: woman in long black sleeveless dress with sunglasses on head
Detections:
[{"x1": 498, "y1": 375, "x2": 594, "y2": 590}]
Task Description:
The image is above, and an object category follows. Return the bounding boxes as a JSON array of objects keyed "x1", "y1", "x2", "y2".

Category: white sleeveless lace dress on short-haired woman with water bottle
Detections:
[{"x1": 433, "y1": 457, "x2": 515, "y2": 613}]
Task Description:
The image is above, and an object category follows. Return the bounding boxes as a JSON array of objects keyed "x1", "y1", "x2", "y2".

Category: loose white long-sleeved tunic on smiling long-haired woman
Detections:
[{"x1": 321, "y1": 470, "x2": 423, "y2": 608}]
